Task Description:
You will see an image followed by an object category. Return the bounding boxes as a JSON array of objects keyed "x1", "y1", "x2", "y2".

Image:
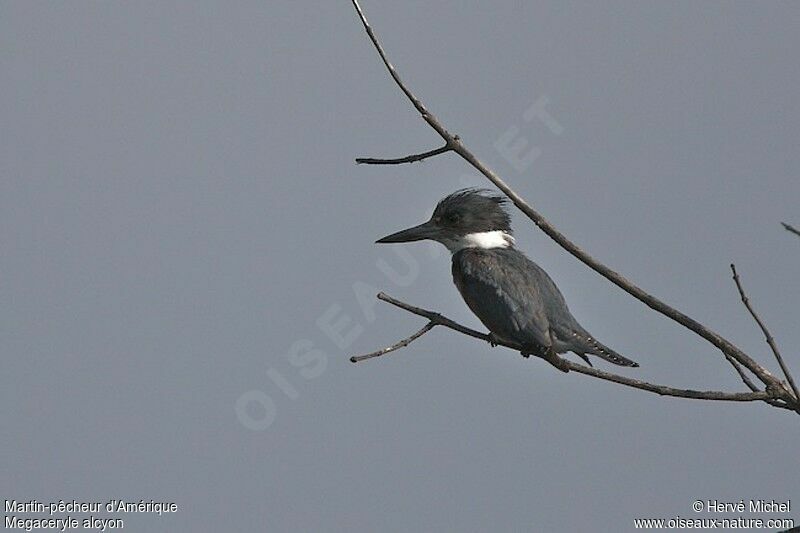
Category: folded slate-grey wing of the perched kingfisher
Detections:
[{"x1": 453, "y1": 248, "x2": 557, "y2": 347}]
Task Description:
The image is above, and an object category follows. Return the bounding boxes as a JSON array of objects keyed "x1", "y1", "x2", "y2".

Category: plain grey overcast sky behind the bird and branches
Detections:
[{"x1": 0, "y1": 0, "x2": 800, "y2": 531}]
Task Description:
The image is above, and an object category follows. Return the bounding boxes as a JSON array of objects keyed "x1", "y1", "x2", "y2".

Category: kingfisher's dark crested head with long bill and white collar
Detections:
[{"x1": 376, "y1": 189, "x2": 514, "y2": 253}]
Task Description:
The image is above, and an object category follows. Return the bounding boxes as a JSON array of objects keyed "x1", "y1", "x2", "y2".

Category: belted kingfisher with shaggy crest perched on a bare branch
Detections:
[{"x1": 377, "y1": 189, "x2": 639, "y2": 366}]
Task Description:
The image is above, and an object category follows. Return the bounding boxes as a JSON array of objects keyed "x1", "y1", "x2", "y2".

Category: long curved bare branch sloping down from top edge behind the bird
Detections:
[{"x1": 351, "y1": 0, "x2": 781, "y2": 387}]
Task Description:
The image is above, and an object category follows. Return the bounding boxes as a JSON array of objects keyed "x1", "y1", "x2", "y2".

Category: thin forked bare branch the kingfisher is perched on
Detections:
[{"x1": 350, "y1": 293, "x2": 789, "y2": 409}]
